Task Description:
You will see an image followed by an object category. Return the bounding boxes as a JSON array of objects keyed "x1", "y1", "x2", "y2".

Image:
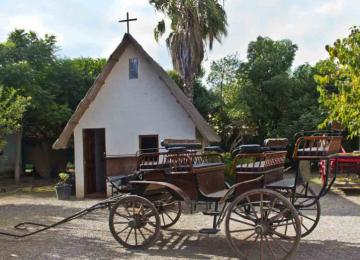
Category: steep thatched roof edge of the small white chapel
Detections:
[{"x1": 53, "y1": 33, "x2": 220, "y2": 149}]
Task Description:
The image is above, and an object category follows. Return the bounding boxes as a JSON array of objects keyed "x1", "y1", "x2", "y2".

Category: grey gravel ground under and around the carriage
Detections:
[{"x1": 0, "y1": 184, "x2": 360, "y2": 260}]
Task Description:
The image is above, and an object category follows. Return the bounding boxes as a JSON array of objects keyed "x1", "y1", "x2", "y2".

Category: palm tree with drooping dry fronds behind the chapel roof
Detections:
[{"x1": 149, "y1": 0, "x2": 227, "y2": 101}]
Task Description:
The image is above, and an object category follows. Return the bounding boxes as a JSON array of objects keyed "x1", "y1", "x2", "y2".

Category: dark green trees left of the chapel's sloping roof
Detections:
[{"x1": 0, "y1": 30, "x2": 105, "y2": 142}]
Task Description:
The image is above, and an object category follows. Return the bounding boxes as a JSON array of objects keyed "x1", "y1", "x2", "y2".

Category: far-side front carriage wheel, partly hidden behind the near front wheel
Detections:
[{"x1": 155, "y1": 192, "x2": 181, "y2": 229}]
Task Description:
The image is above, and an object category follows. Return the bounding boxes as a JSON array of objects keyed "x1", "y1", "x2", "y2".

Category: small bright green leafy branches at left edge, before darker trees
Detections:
[{"x1": 0, "y1": 85, "x2": 30, "y2": 150}]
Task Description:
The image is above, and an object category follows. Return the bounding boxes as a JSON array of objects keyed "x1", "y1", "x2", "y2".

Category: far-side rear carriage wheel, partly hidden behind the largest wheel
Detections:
[{"x1": 289, "y1": 185, "x2": 321, "y2": 237}]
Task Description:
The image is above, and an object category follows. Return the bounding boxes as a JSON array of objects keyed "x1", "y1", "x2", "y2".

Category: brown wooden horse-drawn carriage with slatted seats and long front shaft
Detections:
[{"x1": 0, "y1": 134, "x2": 341, "y2": 259}]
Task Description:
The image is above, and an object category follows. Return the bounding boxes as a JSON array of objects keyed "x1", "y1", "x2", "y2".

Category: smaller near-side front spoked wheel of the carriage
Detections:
[{"x1": 109, "y1": 195, "x2": 160, "y2": 249}]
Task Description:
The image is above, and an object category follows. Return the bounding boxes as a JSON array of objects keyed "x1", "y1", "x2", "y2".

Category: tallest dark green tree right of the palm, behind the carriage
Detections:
[{"x1": 239, "y1": 36, "x2": 297, "y2": 141}]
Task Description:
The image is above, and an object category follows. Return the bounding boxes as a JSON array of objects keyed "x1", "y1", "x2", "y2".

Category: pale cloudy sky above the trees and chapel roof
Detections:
[{"x1": 0, "y1": 0, "x2": 360, "y2": 69}]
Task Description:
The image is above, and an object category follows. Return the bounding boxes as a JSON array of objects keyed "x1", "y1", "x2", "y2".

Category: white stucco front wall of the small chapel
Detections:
[{"x1": 74, "y1": 46, "x2": 195, "y2": 197}]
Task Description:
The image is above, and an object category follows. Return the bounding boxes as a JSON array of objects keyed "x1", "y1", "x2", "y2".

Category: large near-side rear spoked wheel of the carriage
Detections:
[{"x1": 225, "y1": 189, "x2": 301, "y2": 259}]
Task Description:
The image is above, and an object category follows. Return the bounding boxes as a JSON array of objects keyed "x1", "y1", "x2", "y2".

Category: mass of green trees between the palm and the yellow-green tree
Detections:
[{"x1": 208, "y1": 37, "x2": 323, "y2": 151}]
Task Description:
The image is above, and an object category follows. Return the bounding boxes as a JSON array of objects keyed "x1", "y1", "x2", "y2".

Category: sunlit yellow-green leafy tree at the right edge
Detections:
[{"x1": 315, "y1": 27, "x2": 360, "y2": 137}]
